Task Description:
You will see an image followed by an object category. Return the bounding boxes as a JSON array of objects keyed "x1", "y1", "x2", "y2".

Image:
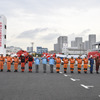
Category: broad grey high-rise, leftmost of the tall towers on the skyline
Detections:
[{"x1": 58, "y1": 36, "x2": 68, "y2": 53}]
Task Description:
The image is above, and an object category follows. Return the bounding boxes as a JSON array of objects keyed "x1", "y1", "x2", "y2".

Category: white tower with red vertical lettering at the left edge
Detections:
[{"x1": 0, "y1": 15, "x2": 7, "y2": 56}]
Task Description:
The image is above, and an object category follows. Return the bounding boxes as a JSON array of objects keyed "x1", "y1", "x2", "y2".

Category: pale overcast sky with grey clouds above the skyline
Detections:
[{"x1": 0, "y1": 0, "x2": 100, "y2": 50}]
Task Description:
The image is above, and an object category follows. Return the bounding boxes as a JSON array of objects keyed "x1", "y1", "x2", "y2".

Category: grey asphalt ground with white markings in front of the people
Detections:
[{"x1": 0, "y1": 64, "x2": 100, "y2": 100}]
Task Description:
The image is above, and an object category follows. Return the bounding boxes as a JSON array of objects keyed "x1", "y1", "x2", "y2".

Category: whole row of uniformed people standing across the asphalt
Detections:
[{"x1": 0, "y1": 54, "x2": 100, "y2": 74}]
